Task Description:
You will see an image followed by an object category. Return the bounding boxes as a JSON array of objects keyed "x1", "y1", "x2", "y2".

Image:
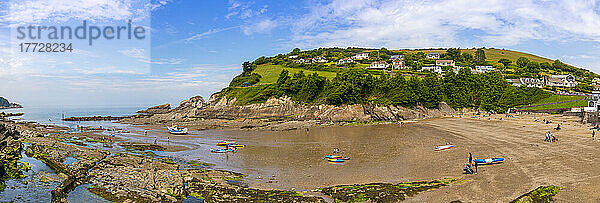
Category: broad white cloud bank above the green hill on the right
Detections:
[{"x1": 292, "y1": 0, "x2": 600, "y2": 48}]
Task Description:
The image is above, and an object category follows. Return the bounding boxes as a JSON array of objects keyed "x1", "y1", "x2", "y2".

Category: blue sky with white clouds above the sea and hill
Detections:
[{"x1": 0, "y1": 0, "x2": 600, "y2": 107}]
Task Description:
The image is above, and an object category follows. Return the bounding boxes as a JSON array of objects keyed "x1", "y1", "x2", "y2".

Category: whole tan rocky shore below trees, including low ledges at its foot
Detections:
[{"x1": 120, "y1": 94, "x2": 457, "y2": 130}]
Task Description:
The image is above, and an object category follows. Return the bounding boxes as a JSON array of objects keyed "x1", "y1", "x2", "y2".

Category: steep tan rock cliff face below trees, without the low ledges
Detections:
[{"x1": 132, "y1": 95, "x2": 456, "y2": 122}]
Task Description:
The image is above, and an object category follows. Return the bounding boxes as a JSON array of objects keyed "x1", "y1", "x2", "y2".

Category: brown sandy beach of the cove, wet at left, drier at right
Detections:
[{"x1": 123, "y1": 114, "x2": 600, "y2": 202}]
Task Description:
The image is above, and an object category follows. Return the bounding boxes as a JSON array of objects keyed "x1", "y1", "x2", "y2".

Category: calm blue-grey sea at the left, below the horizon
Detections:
[{"x1": 0, "y1": 106, "x2": 144, "y2": 127}]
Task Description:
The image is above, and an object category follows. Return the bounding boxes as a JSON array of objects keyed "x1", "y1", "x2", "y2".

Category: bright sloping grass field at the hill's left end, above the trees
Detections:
[{"x1": 252, "y1": 65, "x2": 336, "y2": 84}]
